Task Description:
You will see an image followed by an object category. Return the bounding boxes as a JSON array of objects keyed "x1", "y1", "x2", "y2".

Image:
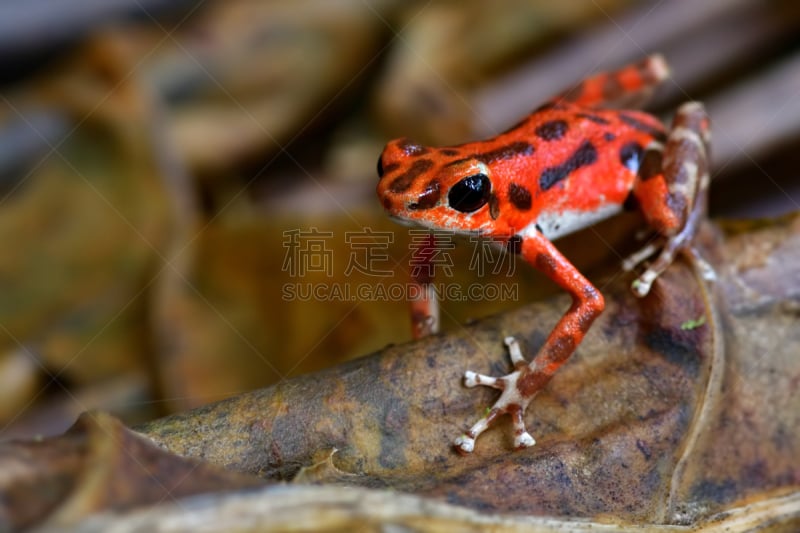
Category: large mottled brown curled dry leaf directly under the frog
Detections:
[{"x1": 131, "y1": 217, "x2": 800, "y2": 524}]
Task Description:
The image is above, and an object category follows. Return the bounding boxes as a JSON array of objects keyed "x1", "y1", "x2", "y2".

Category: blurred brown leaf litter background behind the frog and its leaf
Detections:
[{"x1": 0, "y1": 0, "x2": 800, "y2": 440}]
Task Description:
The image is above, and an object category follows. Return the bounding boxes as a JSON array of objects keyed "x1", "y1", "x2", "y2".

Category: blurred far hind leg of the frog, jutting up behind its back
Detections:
[{"x1": 548, "y1": 54, "x2": 669, "y2": 109}]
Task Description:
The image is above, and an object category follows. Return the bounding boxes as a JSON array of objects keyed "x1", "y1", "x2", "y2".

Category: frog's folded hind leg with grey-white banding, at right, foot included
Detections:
[{"x1": 622, "y1": 102, "x2": 712, "y2": 296}]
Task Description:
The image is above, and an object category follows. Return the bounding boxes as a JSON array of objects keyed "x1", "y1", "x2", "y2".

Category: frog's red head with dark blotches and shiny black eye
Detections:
[{"x1": 378, "y1": 139, "x2": 498, "y2": 234}]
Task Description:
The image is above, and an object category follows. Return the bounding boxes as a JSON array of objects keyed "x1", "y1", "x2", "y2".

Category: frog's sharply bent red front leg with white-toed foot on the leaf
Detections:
[{"x1": 454, "y1": 231, "x2": 604, "y2": 453}]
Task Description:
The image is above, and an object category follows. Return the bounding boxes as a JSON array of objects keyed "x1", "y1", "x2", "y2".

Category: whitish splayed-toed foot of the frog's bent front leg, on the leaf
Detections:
[{"x1": 453, "y1": 337, "x2": 536, "y2": 454}]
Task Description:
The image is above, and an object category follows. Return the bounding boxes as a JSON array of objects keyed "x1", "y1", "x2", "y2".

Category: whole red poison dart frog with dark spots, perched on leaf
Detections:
[{"x1": 377, "y1": 55, "x2": 711, "y2": 453}]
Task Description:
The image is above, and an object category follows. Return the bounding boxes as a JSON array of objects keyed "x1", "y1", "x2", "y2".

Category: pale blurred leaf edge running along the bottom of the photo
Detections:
[{"x1": 36, "y1": 485, "x2": 800, "y2": 533}]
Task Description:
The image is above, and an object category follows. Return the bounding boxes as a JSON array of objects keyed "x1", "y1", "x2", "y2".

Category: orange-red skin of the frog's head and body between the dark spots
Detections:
[{"x1": 378, "y1": 104, "x2": 665, "y2": 238}]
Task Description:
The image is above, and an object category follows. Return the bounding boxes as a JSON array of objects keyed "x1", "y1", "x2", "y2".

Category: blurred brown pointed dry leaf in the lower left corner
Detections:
[{"x1": 0, "y1": 413, "x2": 263, "y2": 531}]
